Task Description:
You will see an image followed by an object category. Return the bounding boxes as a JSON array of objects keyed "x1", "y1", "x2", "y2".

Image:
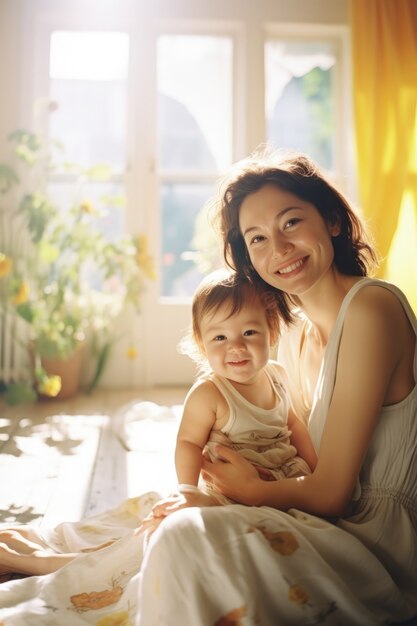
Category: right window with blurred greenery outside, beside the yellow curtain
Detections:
[{"x1": 264, "y1": 24, "x2": 353, "y2": 179}]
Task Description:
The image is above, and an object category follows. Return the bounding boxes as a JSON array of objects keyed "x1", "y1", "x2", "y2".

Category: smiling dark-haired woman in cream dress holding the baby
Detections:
[{"x1": 137, "y1": 151, "x2": 417, "y2": 626}]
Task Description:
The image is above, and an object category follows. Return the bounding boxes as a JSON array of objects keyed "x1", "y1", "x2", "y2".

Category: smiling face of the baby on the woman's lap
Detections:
[{"x1": 201, "y1": 300, "x2": 270, "y2": 383}]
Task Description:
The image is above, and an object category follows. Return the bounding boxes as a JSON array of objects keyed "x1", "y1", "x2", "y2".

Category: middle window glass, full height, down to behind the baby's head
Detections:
[{"x1": 157, "y1": 34, "x2": 233, "y2": 298}]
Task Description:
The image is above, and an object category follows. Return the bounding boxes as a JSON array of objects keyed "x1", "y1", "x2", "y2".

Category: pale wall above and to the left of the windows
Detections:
[{"x1": 0, "y1": 0, "x2": 348, "y2": 136}]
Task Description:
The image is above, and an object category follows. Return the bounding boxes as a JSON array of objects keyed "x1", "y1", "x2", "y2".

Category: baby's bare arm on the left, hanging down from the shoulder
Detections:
[{"x1": 175, "y1": 381, "x2": 217, "y2": 486}]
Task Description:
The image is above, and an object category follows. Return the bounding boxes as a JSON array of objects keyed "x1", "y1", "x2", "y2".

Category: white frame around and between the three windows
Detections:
[{"x1": 14, "y1": 0, "x2": 355, "y2": 386}]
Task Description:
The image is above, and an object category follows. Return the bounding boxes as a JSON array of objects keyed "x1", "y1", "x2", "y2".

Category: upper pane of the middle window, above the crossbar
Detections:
[{"x1": 157, "y1": 35, "x2": 233, "y2": 172}]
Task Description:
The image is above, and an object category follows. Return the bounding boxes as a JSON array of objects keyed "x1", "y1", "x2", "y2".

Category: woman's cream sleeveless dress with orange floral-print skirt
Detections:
[{"x1": 136, "y1": 279, "x2": 417, "y2": 626}]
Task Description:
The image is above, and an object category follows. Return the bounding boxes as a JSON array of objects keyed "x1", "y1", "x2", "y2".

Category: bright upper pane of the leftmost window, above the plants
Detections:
[{"x1": 49, "y1": 31, "x2": 129, "y2": 171}]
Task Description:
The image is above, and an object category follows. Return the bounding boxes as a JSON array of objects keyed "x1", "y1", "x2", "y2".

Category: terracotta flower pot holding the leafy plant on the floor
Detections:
[{"x1": 30, "y1": 341, "x2": 85, "y2": 400}]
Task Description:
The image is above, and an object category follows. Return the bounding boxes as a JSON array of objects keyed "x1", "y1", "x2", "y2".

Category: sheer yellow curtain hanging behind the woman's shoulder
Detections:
[{"x1": 350, "y1": 0, "x2": 417, "y2": 310}]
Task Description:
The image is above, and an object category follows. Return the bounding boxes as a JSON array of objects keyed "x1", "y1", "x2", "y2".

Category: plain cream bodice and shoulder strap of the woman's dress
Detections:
[{"x1": 280, "y1": 278, "x2": 417, "y2": 613}]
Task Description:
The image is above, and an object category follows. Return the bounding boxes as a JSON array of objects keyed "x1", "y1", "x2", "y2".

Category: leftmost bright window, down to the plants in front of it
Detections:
[{"x1": 49, "y1": 31, "x2": 129, "y2": 239}]
